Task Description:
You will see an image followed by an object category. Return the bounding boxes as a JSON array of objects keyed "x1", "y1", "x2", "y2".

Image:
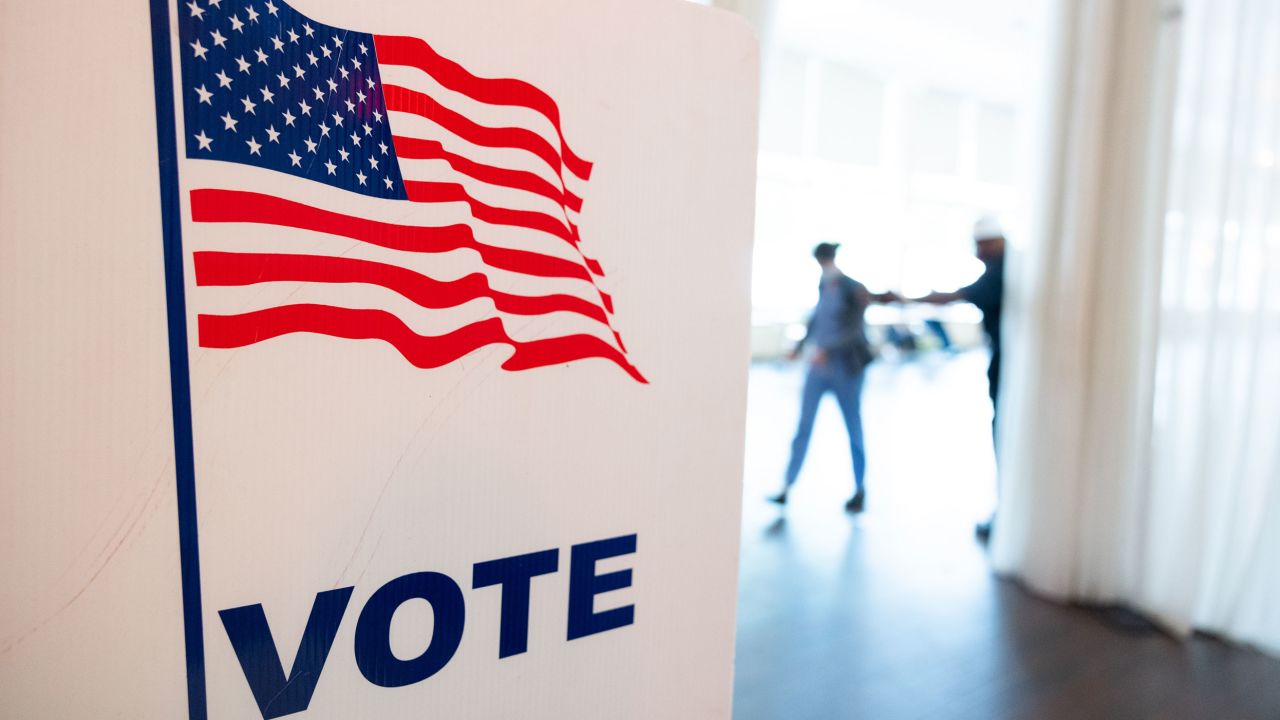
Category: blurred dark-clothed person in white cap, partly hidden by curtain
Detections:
[{"x1": 908, "y1": 215, "x2": 1005, "y2": 541}]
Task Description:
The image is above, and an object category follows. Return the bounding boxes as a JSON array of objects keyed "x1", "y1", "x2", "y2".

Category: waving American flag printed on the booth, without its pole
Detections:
[{"x1": 175, "y1": 0, "x2": 646, "y2": 383}]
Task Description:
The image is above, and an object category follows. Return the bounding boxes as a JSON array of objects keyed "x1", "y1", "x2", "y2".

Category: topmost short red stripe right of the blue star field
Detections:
[{"x1": 374, "y1": 35, "x2": 591, "y2": 179}]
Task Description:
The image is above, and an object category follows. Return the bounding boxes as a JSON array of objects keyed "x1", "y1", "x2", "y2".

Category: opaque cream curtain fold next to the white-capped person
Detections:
[{"x1": 992, "y1": 0, "x2": 1176, "y2": 601}]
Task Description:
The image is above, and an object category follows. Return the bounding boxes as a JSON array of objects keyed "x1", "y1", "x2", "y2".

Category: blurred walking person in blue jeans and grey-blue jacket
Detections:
[{"x1": 769, "y1": 242, "x2": 899, "y2": 512}]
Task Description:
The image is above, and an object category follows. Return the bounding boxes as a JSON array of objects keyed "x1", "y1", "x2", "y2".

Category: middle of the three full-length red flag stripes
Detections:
[{"x1": 195, "y1": 251, "x2": 608, "y2": 325}]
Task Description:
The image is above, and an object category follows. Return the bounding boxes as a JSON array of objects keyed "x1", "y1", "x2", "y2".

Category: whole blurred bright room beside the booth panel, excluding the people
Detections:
[{"x1": 703, "y1": 0, "x2": 1280, "y2": 720}]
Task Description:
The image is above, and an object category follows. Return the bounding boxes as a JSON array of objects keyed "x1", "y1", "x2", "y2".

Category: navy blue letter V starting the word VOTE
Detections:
[{"x1": 218, "y1": 588, "x2": 355, "y2": 720}]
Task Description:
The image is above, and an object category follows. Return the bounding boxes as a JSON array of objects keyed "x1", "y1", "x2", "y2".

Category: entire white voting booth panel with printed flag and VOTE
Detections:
[{"x1": 0, "y1": 0, "x2": 758, "y2": 719}]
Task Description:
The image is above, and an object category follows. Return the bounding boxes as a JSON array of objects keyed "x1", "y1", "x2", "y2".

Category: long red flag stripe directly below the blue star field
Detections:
[{"x1": 191, "y1": 190, "x2": 588, "y2": 280}]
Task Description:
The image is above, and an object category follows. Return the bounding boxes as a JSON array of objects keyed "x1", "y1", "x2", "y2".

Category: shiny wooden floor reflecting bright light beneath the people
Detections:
[{"x1": 735, "y1": 354, "x2": 1280, "y2": 720}]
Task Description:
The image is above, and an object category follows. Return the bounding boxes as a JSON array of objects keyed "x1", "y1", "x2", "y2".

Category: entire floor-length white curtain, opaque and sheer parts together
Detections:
[{"x1": 992, "y1": 0, "x2": 1280, "y2": 653}]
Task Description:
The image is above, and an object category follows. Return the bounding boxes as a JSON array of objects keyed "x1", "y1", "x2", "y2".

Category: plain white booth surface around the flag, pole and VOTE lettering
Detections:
[{"x1": 0, "y1": 0, "x2": 756, "y2": 719}]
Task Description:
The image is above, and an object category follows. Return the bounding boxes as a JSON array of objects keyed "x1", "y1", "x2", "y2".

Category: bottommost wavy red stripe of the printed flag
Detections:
[{"x1": 198, "y1": 305, "x2": 648, "y2": 383}]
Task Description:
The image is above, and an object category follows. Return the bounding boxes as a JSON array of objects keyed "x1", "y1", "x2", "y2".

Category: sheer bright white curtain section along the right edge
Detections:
[{"x1": 1139, "y1": 0, "x2": 1280, "y2": 653}]
